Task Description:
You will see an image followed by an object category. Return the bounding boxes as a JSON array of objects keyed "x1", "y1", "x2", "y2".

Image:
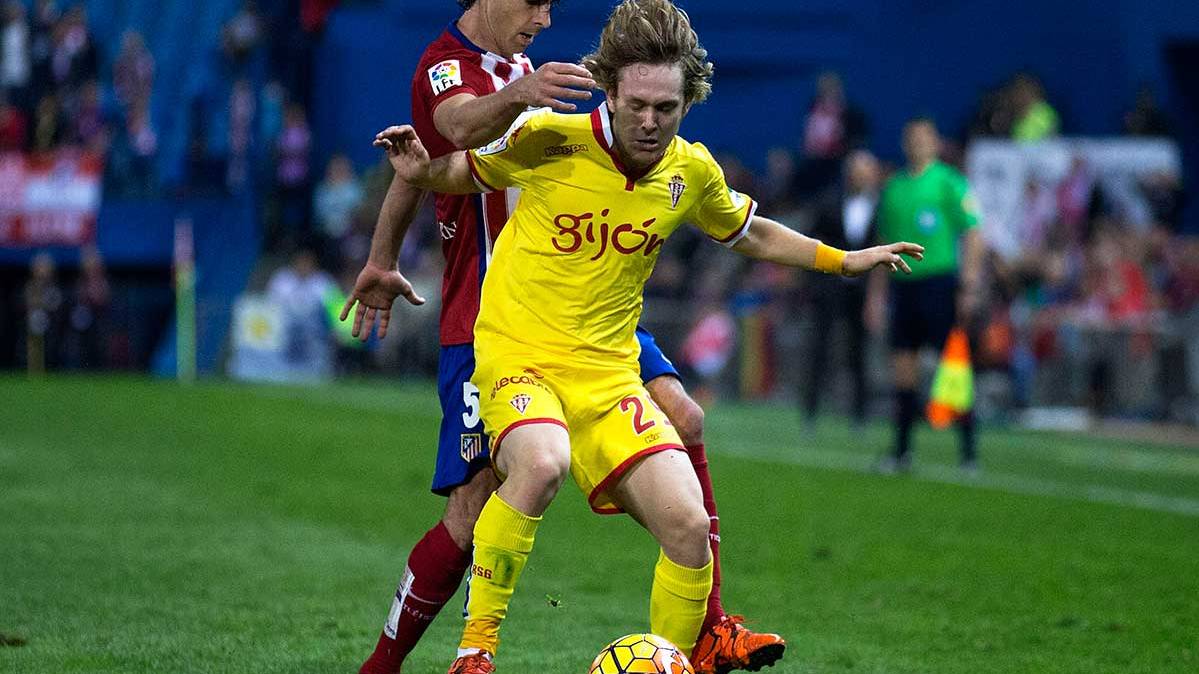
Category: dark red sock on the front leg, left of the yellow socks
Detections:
[{"x1": 359, "y1": 522, "x2": 470, "y2": 674}]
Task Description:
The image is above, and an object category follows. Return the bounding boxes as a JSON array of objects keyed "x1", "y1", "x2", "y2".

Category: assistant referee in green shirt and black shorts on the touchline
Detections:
[{"x1": 867, "y1": 118, "x2": 984, "y2": 473}]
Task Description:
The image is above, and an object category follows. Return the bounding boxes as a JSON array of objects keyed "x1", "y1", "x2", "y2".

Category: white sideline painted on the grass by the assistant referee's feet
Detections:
[{"x1": 716, "y1": 450, "x2": 1199, "y2": 517}]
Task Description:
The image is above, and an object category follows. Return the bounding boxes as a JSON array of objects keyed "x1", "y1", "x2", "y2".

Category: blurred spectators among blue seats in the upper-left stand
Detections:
[{"x1": 0, "y1": 0, "x2": 336, "y2": 196}]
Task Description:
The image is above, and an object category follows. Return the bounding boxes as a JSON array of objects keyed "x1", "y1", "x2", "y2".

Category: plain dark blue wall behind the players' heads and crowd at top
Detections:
[{"x1": 314, "y1": 0, "x2": 1199, "y2": 183}]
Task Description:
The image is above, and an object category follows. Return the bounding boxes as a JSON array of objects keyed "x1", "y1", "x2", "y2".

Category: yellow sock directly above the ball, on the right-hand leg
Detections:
[{"x1": 652, "y1": 549, "x2": 712, "y2": 655}]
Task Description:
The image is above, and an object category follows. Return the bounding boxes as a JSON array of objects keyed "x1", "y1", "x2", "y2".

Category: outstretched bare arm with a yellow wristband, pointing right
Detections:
[{"x1": 733, "y1": 216, "x2": 924, "y2": 276}]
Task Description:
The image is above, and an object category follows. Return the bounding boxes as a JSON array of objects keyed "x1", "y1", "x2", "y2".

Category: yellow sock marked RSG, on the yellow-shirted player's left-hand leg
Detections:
[{"x1": 459, "y1": 493, "x2": 544, "y2": 654}]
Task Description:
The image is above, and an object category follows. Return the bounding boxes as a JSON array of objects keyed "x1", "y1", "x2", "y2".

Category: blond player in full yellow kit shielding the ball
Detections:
[{"x1": 376, "y1": 0, "x2": 922, "y2": 674}]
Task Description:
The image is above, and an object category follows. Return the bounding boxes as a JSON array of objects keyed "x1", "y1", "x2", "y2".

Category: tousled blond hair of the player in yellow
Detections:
[{"x1": 583, "y1": 0, "x2": 712, "y2": 103}]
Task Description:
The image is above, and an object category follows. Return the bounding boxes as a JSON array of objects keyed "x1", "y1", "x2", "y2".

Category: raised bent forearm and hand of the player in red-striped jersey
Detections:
[{"x1": 433, "y1": 62, "x2": 596, "y2": 149}]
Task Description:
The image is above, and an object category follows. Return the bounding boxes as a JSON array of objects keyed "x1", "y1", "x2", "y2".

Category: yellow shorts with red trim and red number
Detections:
[{"x1": 471, "y1": 356, "x2": 683, "y2": 514}]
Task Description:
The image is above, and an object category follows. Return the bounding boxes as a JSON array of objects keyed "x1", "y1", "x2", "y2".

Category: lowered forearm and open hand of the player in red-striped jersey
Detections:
[{"x1": 341, "y1": 174, "x2": 426, "y2": 341}]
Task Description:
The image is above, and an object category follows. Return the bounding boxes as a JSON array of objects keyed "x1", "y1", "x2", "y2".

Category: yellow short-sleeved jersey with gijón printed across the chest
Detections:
[{"x1": 466, "y1": 104, "x2": 757, "y2": 369}]
